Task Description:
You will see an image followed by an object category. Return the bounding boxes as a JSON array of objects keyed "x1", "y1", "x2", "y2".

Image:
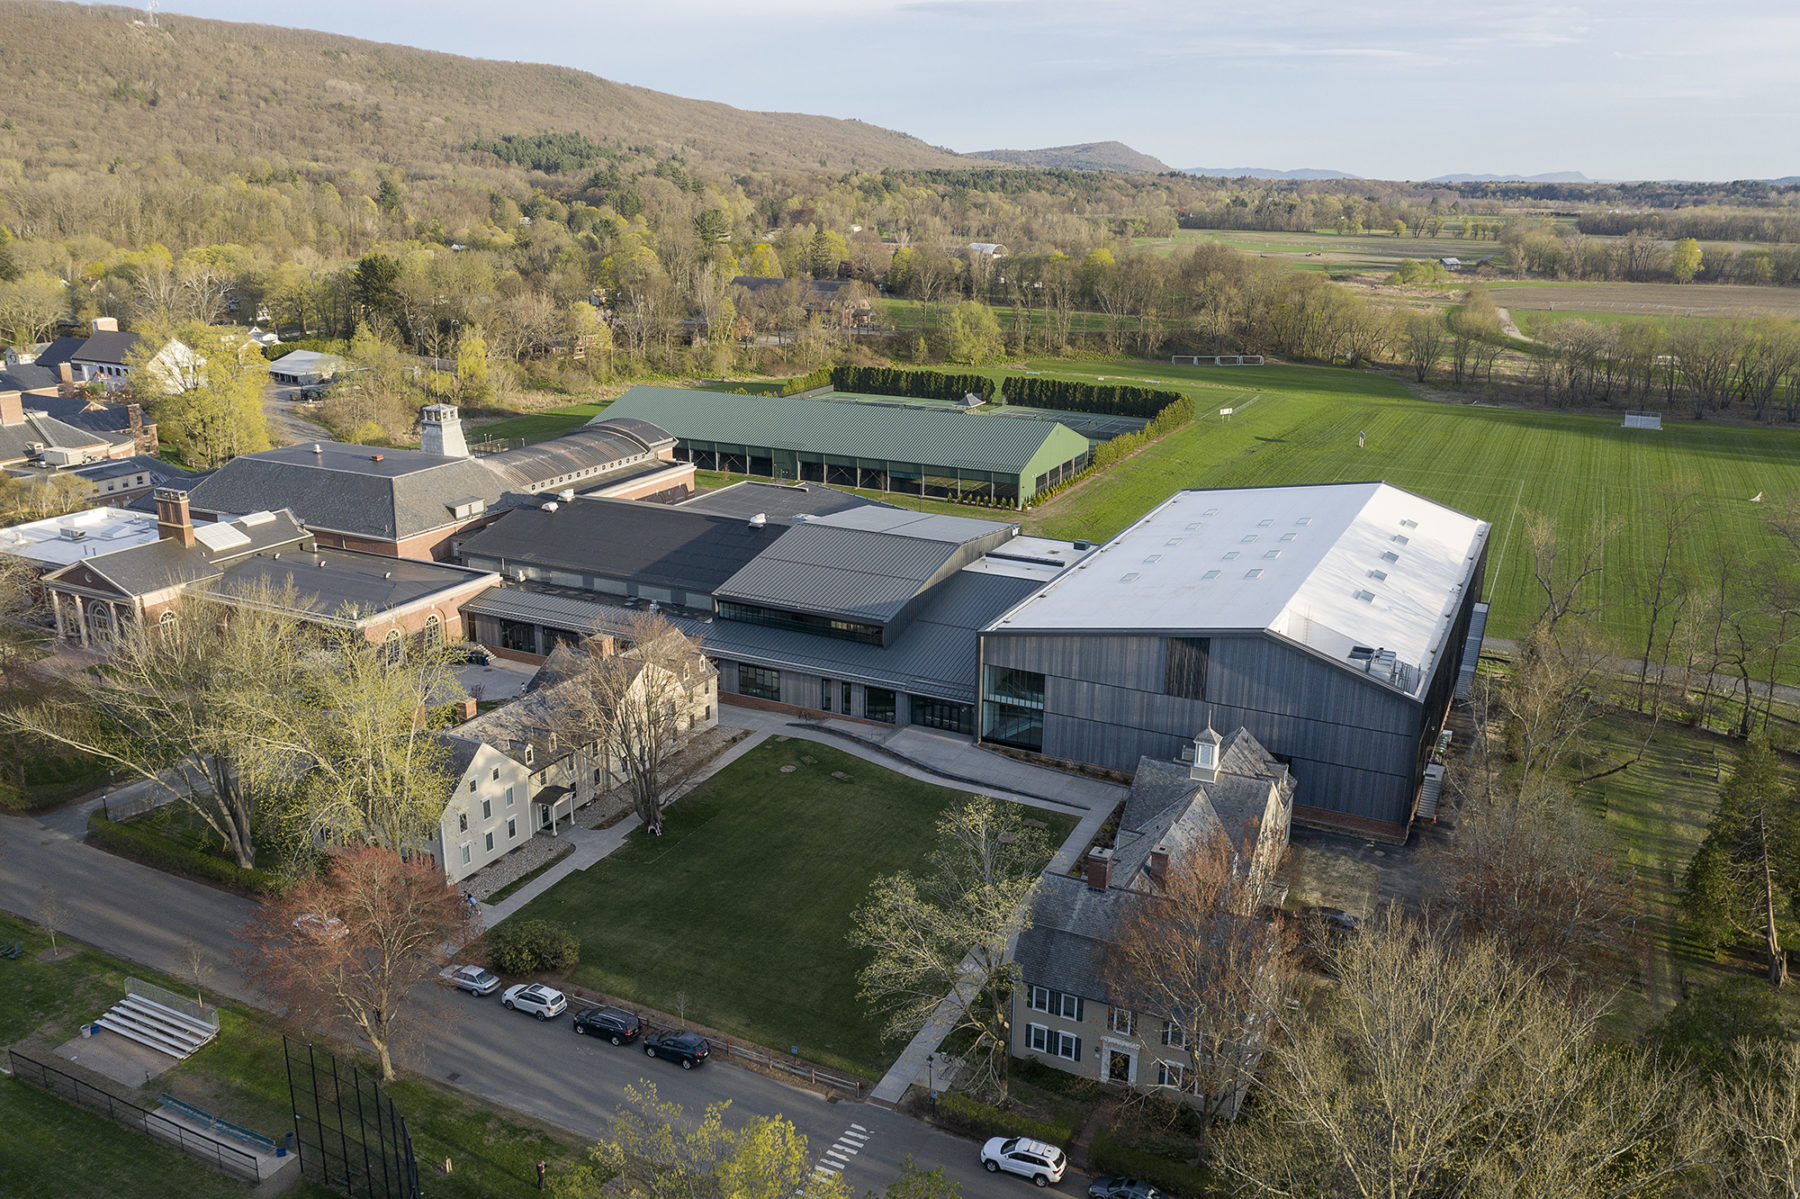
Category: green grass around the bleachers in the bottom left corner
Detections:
[{"x1": 0, "y1": 915, "x2": 572, "y2": 1199}]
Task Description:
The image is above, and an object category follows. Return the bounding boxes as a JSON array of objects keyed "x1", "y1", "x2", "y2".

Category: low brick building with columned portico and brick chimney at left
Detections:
[{"x1": 41, "y1": 488, "x2": 499, "y2": 652}]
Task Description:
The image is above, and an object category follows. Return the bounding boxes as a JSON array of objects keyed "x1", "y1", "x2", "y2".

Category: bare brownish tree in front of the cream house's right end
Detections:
[{"x1": 563, "y1": 612, "x2": 715, "y2": 828}]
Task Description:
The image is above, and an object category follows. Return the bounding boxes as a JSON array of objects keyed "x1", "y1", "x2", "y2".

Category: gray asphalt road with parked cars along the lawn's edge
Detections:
[{"x1": 0, "y1": 792, "x2": 1087, "y2": 1199}]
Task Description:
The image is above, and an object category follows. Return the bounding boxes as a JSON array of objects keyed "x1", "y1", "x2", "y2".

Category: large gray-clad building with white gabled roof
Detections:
[{"x1": 979, "y1": 482, "x2": 1489, "y2": 837}]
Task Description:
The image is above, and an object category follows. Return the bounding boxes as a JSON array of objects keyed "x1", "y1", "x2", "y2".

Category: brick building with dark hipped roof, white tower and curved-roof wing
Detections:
[{"x1": 182, "y1": 405, "x2": 693, "y2": 562}]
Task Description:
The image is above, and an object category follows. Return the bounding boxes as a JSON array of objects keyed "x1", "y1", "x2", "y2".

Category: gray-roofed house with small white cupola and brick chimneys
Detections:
[{"x1": 1012, "y1": 729, "x2": 1294, "y2": 1111}]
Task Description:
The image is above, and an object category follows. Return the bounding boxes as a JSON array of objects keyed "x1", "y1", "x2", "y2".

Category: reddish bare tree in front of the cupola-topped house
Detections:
[{"x1": 1103, "y1": 834, "x2": 1292, "y2": 1158}]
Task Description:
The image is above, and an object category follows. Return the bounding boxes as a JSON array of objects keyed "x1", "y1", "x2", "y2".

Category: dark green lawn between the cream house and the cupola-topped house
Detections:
[{"x1": 520, "y1": 740, "x2": 1075, "y2": 1078}]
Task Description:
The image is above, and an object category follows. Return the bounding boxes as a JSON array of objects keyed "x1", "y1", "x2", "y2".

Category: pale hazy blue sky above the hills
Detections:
[{"x1": 164, "y1": 0, "x2": 1800, "y2": 178}]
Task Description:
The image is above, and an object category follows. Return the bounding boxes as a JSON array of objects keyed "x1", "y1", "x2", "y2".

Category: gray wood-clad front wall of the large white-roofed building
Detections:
[{"x1": 983, "y1": 634, "x2": 1422, "y2": 823}]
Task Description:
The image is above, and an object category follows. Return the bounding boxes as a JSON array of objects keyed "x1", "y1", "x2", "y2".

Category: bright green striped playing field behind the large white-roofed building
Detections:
[{"x1": 1000, "y1": 362, "x2": 1800, "y2": 654}]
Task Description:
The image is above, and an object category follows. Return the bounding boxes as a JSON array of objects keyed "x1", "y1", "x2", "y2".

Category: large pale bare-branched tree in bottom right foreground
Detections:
[{"x1": 1219, "y1": 916, "x2": 1706, "y2": 1199}]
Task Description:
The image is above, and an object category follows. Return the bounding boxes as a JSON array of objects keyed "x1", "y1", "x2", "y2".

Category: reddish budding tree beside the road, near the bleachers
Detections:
[{"x1": 236, "y1": 846, "x2": 477, "y2": 1082}]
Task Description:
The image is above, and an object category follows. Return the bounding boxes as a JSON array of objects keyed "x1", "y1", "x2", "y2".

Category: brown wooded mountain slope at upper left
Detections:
[{"x1": 0, "y1": 0, "x2": 968, "y2": 175}]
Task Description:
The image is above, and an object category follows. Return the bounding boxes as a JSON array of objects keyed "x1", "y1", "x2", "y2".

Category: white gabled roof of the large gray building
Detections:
[{"x1": 988, "y1": 482, "x2": 1489, "y2": 695}]
